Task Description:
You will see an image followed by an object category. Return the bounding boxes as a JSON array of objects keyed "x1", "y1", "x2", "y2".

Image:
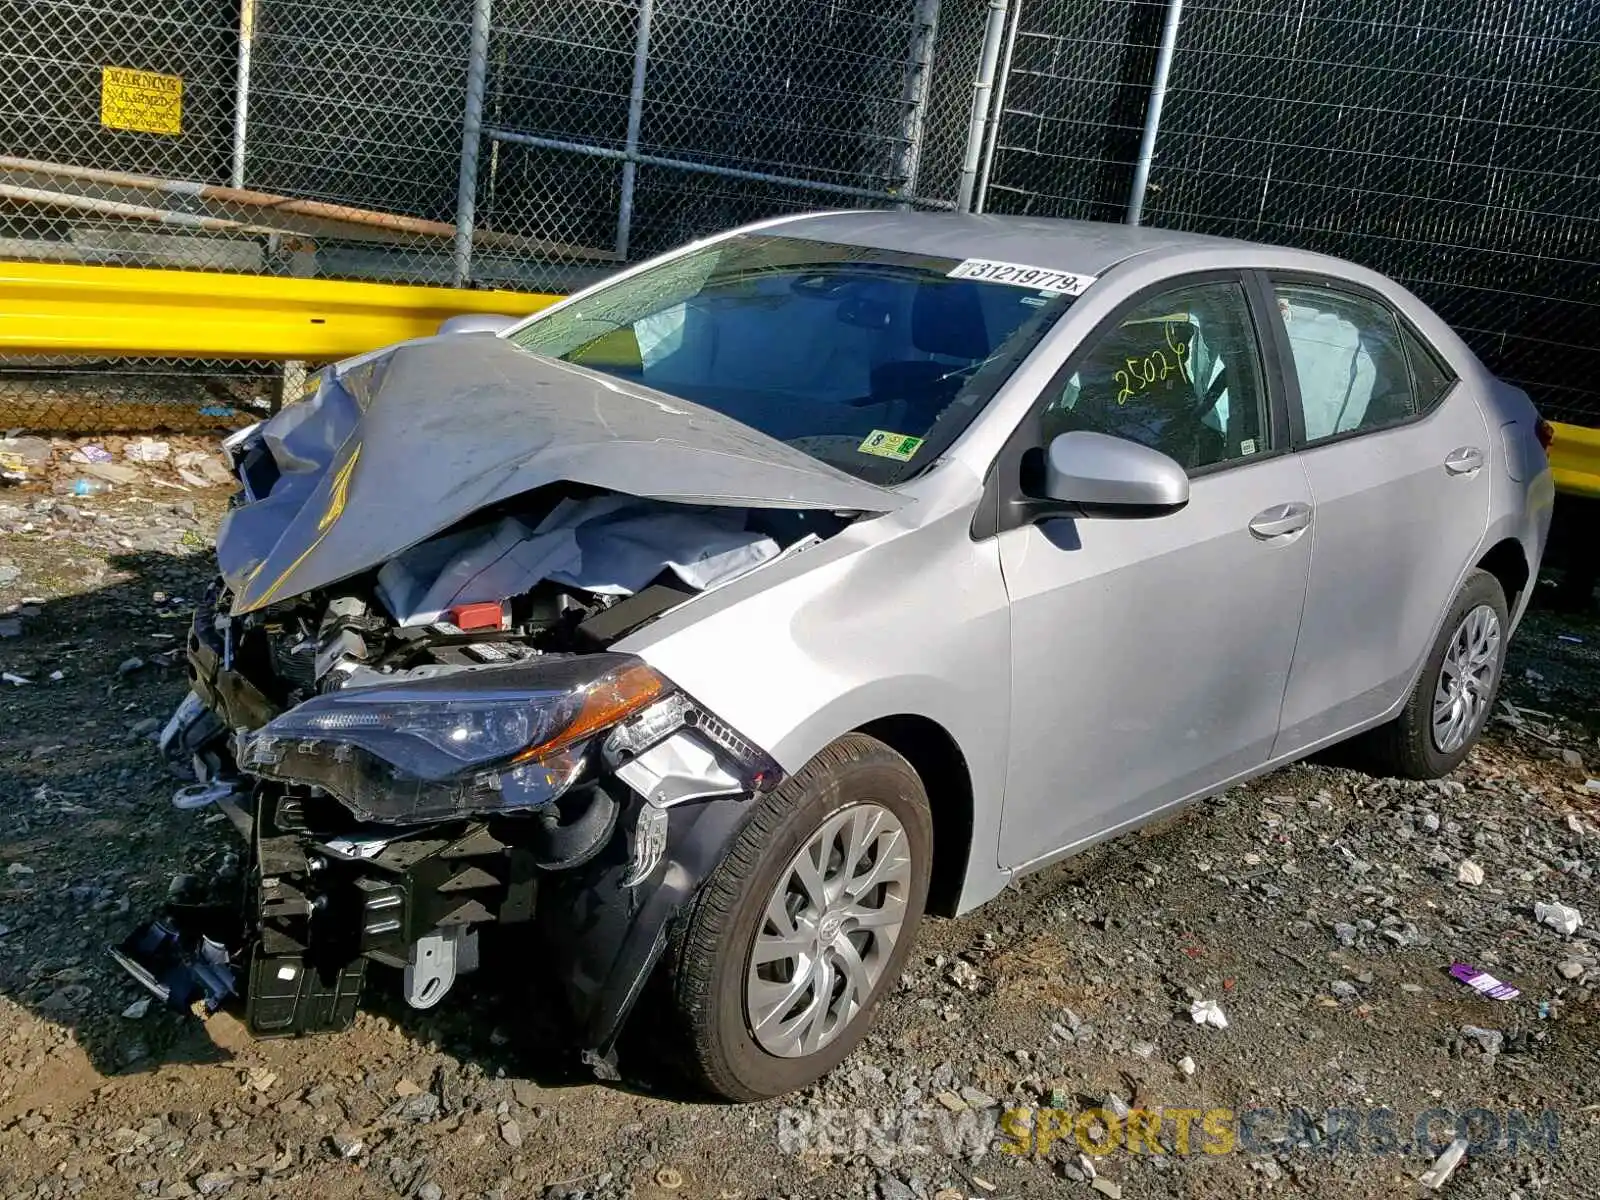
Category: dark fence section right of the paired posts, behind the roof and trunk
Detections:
[{"x1": 987, "y1": 0, "x2": 1600, "y2": 424}]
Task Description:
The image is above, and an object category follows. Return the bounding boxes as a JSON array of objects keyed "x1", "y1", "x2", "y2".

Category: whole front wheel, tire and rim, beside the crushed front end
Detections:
[{"x1": 669, "y1": 734, "x2": 933, "y2": 1101}]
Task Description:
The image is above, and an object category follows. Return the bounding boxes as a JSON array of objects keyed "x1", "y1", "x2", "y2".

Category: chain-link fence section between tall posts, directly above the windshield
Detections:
[{"x1": 470, "y1": 0, "x2": 939, "y2": 288}]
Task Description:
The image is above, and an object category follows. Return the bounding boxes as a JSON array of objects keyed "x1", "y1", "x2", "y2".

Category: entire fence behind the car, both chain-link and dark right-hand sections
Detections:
[{"x1": 0, "y1": 0, "x2": 1600, "y2": 429}]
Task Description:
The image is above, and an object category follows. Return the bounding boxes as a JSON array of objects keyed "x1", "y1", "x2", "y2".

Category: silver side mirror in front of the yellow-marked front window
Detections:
[{"x1": 1045, "y1": 430, "x2": 1189, "y2": 517}]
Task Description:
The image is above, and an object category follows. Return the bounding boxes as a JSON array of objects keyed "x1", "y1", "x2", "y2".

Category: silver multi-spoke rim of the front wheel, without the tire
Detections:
[{"x1": 744, "y1": 803, "x2": 910, "y2": 1058}]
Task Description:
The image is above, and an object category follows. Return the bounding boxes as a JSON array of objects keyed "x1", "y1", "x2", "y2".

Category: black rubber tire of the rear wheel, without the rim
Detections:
[{"x1": 1360, "y1": 570, "x2": 1510, "y2": 779}]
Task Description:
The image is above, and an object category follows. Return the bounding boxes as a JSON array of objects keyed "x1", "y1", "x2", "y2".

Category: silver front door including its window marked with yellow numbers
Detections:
[{"x1": 1000, "y1": 278, "x2": 1310, "y2": 867}]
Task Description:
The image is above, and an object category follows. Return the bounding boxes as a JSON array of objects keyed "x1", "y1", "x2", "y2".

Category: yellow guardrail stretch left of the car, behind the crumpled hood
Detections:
[{"x1": 0, "y1": 262, "x2": 558, "y2": 362}]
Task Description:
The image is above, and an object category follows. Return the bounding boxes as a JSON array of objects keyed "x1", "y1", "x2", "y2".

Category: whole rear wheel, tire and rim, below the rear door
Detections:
[{"x1": 1368, "y1": 571, "x2": 1510, "y2": 779}]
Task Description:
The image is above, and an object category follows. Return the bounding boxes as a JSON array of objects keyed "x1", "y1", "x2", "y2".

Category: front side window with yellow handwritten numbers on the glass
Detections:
[{"x1": 1042, "y1": 282, "x2": 1269, "y2": 470}]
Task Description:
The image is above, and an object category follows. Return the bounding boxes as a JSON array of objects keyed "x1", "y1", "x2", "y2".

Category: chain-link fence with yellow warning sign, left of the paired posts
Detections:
[{"x1": 0, "y1": 0, "x2": 976, "y2": 429}]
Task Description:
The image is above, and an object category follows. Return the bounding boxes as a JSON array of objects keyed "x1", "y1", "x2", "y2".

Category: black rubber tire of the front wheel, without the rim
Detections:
[{"x1": 666, "y1": 733, "x2": 933, "y2": 1101}]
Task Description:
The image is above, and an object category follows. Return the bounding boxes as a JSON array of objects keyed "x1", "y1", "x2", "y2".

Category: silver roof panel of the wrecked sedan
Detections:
[{"x1": 763, "y1": 211, "x2": 1251, "y2": 275}]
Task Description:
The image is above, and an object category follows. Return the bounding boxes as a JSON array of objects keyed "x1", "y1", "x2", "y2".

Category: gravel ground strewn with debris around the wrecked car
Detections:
[{"x1": 0, "y1": 469, "x2": 1600, "y2": 1200}]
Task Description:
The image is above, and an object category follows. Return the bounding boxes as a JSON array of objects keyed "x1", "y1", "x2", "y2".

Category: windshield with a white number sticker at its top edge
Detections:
[{"x1": 510, "y1": 234, "x2": 1072, "y2": 483}]
